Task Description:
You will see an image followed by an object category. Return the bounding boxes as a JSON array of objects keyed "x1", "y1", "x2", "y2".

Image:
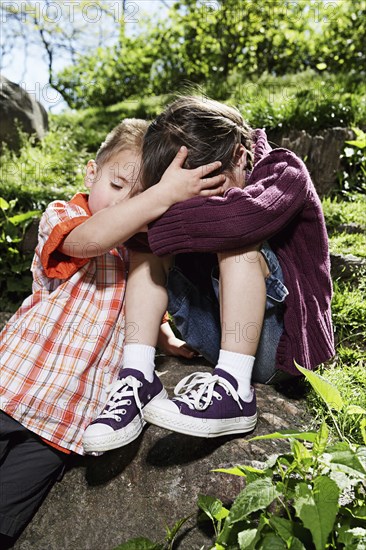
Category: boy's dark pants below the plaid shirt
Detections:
[{"x1": 0, "y1": 411, "x2": 68, "y2": 548}]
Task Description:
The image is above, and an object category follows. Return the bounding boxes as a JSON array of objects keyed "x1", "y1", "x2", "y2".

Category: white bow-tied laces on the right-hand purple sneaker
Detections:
[{"x1": 174, "y1": 372, "x2": 243, "y2": 411}]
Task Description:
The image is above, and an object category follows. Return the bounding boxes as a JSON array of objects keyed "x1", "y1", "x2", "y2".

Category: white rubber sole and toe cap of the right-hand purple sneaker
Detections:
[{"x1": 144, "y1": 401, "x2": 257, "y2": 438}]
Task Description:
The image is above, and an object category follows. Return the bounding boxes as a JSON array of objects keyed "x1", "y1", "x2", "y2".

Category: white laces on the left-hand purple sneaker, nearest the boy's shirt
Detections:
[{"x1": 99, "y1": 376, "x2": 142, "y2": 421}]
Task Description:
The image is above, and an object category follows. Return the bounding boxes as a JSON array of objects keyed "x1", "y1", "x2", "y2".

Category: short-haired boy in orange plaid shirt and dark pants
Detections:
[{"x1": 0, "y1": 119, "x2": 224, "y2": 548}]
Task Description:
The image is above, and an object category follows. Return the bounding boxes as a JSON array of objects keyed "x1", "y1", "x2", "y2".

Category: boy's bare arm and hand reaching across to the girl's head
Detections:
[{"x1": 59, "y1": 147, "x2": 225, "y2": 258}]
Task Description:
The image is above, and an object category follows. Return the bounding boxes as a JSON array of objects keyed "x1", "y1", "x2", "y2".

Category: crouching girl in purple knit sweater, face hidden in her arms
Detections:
[{"x1": 85, "y1": 97, "x2": 334, "y2": 447}]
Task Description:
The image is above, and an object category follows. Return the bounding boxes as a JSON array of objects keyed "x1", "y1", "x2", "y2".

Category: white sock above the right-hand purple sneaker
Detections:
[{"x1": 216, "y1": 349, "x2": 255, "y2": 401}]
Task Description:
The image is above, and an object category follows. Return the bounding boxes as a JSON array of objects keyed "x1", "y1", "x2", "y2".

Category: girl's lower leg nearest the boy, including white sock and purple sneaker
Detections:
[{"x1": 83, "y1": 252, "x2": 170, "y2": 453}]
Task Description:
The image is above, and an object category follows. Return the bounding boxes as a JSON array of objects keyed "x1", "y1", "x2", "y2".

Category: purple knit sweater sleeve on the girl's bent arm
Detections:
[{"x1": 148, "y1": 149, "x2": 312, "y2": 256}]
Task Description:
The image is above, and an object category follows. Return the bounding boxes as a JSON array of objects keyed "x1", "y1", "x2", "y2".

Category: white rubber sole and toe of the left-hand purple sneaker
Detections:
[{"x1": 83, "y1": 388, "x2": 168, "y2": 454}]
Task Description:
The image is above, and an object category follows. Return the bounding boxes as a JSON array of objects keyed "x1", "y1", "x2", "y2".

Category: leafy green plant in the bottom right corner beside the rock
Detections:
[{"x1": 198, "y1": 366, "x2": 366, "y2": 550}]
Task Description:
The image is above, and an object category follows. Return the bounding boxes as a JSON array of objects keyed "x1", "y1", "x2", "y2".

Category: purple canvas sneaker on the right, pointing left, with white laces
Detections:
[{"x1": 144, "y1": 368, "x2": 257, "y2": 437}]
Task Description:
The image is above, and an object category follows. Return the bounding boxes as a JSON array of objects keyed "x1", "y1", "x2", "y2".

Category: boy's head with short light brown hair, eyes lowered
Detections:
[{"x1": 85, "y1": 118, "x2": 148, "y2": 214}]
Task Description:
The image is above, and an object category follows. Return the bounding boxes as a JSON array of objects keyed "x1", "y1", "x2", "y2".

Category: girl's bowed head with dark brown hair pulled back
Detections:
[{"x1": 142, "y1": 96, "x2": 253, "y2": 188}]
